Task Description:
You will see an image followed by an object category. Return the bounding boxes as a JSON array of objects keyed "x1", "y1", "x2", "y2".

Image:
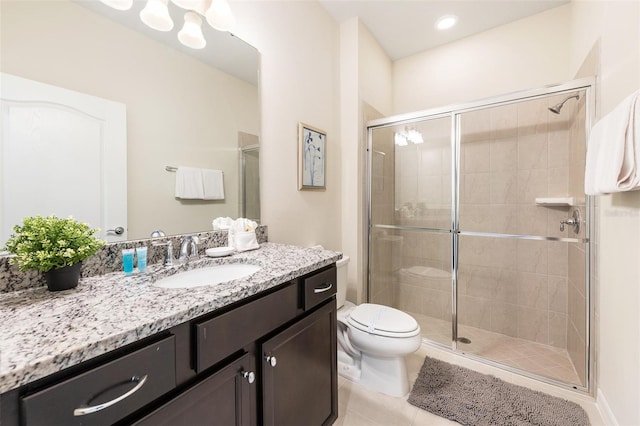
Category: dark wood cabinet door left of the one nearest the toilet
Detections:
[{"x1": 134, "y1": 354, "x2": 257, "y2": 426}]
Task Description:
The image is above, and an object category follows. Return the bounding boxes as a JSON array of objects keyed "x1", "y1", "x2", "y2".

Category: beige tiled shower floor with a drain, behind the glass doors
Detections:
[{"x1": 409, "y1": 312, "x2": 583, "y2": 385}]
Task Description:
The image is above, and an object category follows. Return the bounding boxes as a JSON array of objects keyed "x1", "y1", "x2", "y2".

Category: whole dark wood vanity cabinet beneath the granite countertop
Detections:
[{"x1": 0, "y1": 265, "x2": 338, "y2": 426}]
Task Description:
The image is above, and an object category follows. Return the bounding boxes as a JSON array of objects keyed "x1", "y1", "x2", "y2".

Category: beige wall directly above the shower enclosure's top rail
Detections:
[{"x1": 393, "y1": 5, "x2": 570, "y2": 114}]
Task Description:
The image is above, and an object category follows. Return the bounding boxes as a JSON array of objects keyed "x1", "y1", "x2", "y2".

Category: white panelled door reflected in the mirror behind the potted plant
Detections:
[{"x1": 0, "y1": 73, "x2": 127, "y2": 246}]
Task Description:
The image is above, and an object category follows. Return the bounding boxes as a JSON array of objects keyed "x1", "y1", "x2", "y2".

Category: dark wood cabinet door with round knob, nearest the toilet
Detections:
[{"x1": 261, "y1": 299, "x2": 338, "y2": 426}]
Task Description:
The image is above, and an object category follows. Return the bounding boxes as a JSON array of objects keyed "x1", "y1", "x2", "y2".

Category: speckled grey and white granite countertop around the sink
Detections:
[{"x1": 0, "y1": 243, "x2": 342, "y2": 393}]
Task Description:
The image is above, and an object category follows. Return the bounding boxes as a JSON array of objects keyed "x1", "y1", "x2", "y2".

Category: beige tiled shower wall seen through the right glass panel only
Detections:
[{"x1": 458, "y1": 96, "x2": 575, "y2": 348}]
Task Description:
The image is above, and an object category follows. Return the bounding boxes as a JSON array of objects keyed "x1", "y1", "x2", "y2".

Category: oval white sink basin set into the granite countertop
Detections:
[{"x1": 153, "y1": 263, "x2": 261, "y2": 288}]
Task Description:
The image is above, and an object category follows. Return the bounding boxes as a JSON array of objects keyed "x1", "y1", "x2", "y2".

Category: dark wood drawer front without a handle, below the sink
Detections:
[{"x1": 195, "y1": 284, "x2": 301, "y2": 373}]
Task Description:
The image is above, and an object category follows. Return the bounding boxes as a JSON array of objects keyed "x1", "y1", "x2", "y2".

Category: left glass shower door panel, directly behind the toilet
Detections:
[{"x1": 368, "y1": 115, "x2": 453, "y2": 346}]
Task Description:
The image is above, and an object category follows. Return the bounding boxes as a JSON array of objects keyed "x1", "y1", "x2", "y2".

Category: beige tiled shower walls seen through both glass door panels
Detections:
[{"x1": 371, "y1": 95, "x2": 585, "y2": 371}]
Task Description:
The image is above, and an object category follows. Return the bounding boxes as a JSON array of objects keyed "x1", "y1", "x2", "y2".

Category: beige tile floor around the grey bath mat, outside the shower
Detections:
[{"x1": 334, "y1": 344, "x2": 605, "y2": 426}]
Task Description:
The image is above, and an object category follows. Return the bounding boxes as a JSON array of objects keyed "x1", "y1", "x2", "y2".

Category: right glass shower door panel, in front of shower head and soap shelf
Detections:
[{"x1": 456, "y1": 93, "x2": 588, "y2": 386}]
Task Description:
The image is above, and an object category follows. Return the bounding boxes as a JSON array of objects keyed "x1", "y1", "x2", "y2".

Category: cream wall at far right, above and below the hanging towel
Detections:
[{"x1": 571, "y1": 1, "x2": 640, "y2": 425}]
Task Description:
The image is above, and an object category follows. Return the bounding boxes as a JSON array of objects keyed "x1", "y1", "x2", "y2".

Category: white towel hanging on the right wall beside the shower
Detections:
[{"x1": 584, "y1": 91, "x2": 640, "y2": 195}]
